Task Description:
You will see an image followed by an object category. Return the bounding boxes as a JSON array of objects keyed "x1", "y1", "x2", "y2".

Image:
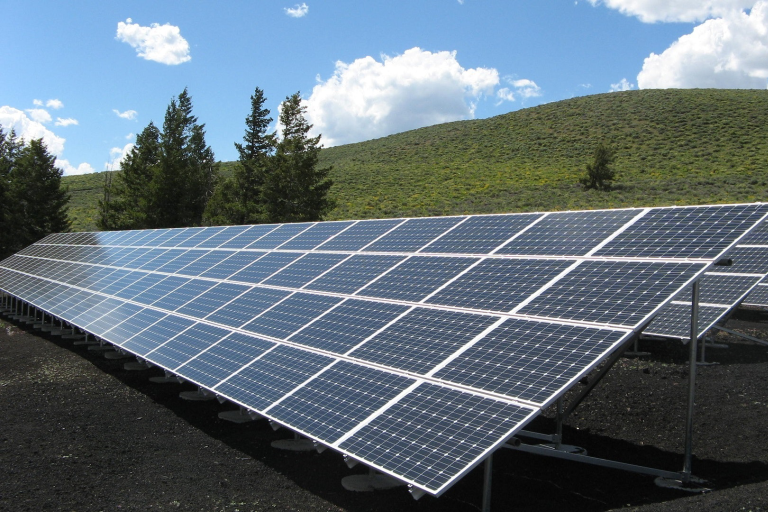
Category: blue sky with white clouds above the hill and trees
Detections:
[{"x1": 0, "y1": 0, "x2": 768, "y2": 174}]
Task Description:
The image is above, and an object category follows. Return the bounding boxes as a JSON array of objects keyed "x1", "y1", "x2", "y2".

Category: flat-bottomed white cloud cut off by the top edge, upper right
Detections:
[{"x1": 589, "y1": 0, "x2": 755, "y2": 23}]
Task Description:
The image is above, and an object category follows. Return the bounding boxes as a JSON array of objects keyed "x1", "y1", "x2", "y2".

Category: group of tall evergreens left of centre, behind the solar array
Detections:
[{"x1": 97, "y1": 87, "x2": 334, "y2": 230}]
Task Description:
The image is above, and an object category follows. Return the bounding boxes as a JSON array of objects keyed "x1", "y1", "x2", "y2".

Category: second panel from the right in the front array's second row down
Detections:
[{"x1": 426, "y1": 259, "x2": 573, "y2": 311}]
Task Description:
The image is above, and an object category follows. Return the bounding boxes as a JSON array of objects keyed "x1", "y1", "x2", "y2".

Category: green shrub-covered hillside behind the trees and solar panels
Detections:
[{"x1": 64, "y1": 89, "x2": 768, "y2": 230}]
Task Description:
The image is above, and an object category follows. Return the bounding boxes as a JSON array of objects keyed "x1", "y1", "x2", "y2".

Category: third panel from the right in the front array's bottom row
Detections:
[{"x1": 214, "y1": 346, "x2": 333, "y2": 411}]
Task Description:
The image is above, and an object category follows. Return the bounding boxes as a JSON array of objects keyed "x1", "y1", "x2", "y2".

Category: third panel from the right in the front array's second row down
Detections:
[{"x1": 356, "y1": 256, "x2": 477, "y2": 302}]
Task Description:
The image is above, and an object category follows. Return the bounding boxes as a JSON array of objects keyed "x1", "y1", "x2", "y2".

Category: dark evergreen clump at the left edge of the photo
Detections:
[{"x1": 0, "y1": 126, "x2": 70, "y2": 260}]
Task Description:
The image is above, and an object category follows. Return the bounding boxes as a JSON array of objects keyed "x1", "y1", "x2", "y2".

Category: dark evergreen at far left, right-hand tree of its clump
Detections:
[{"x1": 9, "y1": 139, "x2": 70, "y2": 252}]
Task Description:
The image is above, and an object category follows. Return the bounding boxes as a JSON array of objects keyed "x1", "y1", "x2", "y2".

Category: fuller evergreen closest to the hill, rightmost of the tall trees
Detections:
[{"x1": 262, "y1": 92, "x2": 334, "y2": 222}]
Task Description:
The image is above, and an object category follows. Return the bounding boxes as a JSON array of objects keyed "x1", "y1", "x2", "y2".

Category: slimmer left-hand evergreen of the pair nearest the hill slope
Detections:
[{"x1": 205, "y1": 87, "x2": 275, "y2": 225}]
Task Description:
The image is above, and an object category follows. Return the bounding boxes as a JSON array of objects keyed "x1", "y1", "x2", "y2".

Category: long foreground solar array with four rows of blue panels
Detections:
[{"x1": 0, "y1": 204, "x2": 768, "y2": 495}]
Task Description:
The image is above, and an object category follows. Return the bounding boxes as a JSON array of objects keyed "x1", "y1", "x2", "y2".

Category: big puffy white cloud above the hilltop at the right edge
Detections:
[{"x1": 637, "y1": 0, "x2": 768, "y2": 89}]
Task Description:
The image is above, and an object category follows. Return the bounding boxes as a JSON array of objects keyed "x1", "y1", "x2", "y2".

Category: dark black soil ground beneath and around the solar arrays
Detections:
[{"x1": 0, "y1": 310, "x2": 768, "y2": 512}]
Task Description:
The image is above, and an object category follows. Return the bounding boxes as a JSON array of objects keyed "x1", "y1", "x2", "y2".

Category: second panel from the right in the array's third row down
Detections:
[{"x1": 349, "y1": 308, "x2": 498, "y2": 374}]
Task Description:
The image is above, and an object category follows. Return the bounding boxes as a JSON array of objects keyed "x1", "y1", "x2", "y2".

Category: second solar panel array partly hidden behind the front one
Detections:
[{"x1": 643, "y1": 223, "x2": 768, "y2": 341}]
